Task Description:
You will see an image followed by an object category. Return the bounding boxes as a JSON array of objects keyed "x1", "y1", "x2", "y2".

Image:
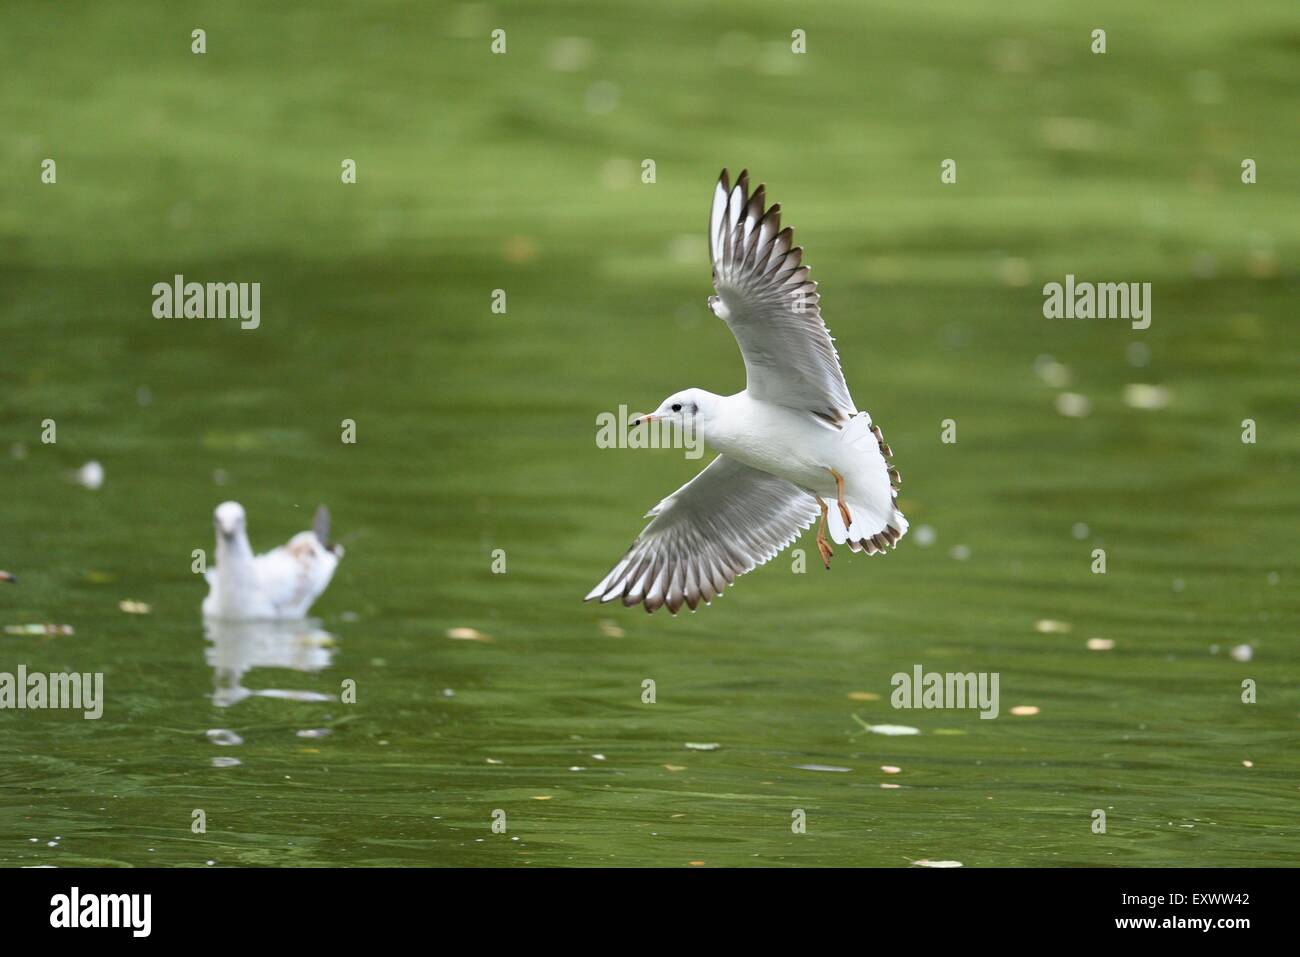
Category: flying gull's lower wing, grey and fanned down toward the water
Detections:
[{"x1": 584, "y1": 455, "x2": 819, "y2": 615}]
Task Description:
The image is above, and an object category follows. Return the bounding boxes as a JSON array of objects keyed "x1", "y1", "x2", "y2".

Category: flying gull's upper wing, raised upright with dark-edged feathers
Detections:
[{"x1": 709, "y1": 169, "x2": 857, "y2": 424}]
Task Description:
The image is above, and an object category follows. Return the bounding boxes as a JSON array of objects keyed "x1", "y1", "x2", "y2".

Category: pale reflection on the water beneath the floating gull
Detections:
[{"x1": 203, "y1": 619, "x2": 335, "y2": 707}]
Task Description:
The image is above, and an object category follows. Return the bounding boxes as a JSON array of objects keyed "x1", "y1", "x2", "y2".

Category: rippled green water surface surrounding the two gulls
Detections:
[{"x1": 0, "y1": 0, "x2": 1300, "y2": 866}]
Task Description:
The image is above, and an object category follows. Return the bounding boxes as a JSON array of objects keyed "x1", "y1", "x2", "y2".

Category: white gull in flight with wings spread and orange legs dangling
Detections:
[{"x1": 585, "y1": 169, "x2": 907, "y2": 615}]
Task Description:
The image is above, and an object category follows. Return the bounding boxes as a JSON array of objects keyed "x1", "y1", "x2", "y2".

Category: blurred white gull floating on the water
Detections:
[{"x1": 203, "y1": 502, "x2": 343, "y2": 622}]
